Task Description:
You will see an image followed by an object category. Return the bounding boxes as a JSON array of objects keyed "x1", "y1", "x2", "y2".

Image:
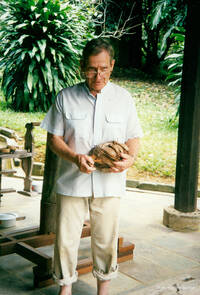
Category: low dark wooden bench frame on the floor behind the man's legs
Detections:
[{"x1": 0, "y1": 221, "x2": 135, "y2": 288}]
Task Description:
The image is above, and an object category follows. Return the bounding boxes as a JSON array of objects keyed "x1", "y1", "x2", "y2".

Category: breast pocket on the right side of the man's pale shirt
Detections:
[{"x1": 104, "y1": 114, "x2": 125, "y2": 142}]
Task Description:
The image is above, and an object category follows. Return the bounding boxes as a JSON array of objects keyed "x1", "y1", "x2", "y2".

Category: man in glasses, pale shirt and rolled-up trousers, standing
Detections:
[{"x1": 41, "y1": 38, "x2": 142, "y2": 295}]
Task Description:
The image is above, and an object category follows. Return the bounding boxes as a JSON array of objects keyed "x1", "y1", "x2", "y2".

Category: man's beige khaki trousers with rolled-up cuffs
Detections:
[{"x1": 53, "y1": 195, "x2": 120, "y2": 286}]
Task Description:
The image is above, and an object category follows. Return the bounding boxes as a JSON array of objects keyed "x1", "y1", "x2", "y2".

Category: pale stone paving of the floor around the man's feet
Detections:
[{"x1": 0, "y1": 177, "x2": 200, "y2": 295}]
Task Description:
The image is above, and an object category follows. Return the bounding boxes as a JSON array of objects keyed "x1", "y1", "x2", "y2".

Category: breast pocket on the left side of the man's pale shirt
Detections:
[{"x1": 64, "y1": 112, "x2": 88, "y2": 138}]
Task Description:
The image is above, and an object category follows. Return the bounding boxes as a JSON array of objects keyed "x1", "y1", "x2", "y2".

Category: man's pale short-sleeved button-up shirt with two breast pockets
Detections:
[{"x1": 41, "y1": 82, "x2": 142, "y2": 197}]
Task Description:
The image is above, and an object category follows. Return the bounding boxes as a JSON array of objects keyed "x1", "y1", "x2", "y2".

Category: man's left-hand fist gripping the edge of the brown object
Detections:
[{"x1": 75, "y1": 154, "x2": 96, "y2": 174}]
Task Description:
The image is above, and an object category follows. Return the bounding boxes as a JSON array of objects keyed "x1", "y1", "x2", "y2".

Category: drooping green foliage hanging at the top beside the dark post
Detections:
[{"x1": 143, "y1": 0, "x2": 187, "y2": 73}]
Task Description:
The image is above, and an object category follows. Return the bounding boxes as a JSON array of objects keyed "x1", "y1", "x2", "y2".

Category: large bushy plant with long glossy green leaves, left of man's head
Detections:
[{"x1": 0, "y1": 0, "x2": 95, "y2": 111}]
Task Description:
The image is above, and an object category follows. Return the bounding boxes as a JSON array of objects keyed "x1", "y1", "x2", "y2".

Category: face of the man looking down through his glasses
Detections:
[{"x1": 83, "y1": 50, "x2": 115, "y2": 96}]
